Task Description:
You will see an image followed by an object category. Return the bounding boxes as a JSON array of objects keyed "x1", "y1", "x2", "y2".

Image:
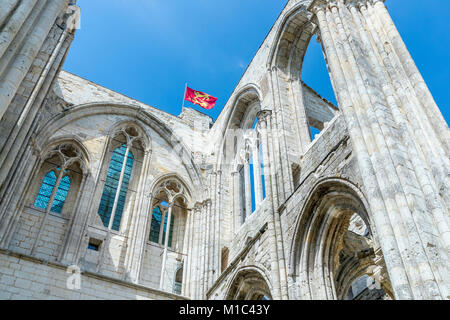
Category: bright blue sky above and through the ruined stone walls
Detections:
[{"x1": 64, "y1": 0, "x2": 450, "y2": 123}]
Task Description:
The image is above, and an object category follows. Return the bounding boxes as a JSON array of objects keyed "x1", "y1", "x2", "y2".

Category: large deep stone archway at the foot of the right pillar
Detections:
[{"x1": 291, "y1": 179, "x2": 393, "y2": 300}]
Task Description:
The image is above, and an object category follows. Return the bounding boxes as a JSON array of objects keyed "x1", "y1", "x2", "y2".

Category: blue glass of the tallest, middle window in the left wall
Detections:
[{"x1": 98, "y1": 144, "x2": 134, "y2": 231}]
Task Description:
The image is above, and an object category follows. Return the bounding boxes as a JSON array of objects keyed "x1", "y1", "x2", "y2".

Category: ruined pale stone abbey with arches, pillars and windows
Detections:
[{"x1": 0, "y1": 0, "x2": 450, "y2": 300}]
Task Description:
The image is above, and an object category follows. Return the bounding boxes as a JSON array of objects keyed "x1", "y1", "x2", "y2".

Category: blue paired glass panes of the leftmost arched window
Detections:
[{"x1": 34, "y1": 168, "x2": 70, "y2": 213}]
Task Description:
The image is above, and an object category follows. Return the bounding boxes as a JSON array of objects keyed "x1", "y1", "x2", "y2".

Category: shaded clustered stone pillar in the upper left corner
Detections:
[{"x1": 0, "y1": 0, "x2": 79, "y2": 202}]
